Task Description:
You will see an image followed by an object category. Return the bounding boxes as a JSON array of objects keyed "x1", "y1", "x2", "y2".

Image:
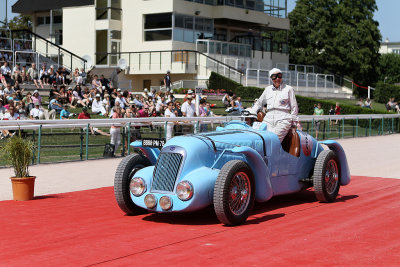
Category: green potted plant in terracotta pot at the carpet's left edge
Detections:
[{"x1": 1, "y1": 133, "x2": 36, "y2": 200}]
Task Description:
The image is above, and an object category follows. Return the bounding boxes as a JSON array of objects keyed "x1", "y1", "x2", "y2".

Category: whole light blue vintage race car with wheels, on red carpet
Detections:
[{"x1": 114, "y1": 121, "x2": 350, "y2": 225}]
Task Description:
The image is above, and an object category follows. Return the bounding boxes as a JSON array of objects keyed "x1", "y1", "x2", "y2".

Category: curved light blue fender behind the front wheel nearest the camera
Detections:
[{"x1": 232, "y1": 146, "x2": 273, "y2": 202}]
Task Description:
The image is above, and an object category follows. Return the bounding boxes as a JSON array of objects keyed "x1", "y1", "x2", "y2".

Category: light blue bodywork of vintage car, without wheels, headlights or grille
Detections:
[{"x1": 131, "y1": 121, "x2": 350, "y2": 212}]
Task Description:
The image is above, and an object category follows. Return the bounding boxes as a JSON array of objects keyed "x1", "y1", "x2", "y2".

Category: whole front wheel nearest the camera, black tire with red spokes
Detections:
[{"x1": 213, "y1": 160, "x2": 255, "y2": 225}]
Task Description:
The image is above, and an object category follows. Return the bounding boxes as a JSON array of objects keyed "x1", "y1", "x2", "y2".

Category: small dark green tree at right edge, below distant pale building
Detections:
[{"x1": 378, "y1": 54, "x2": 400, "y2": 83}]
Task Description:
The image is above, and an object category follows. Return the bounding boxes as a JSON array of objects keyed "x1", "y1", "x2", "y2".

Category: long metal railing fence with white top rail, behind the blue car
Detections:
[{"x1": 0, "y1": 114, "x2": 400, "y2": 166}]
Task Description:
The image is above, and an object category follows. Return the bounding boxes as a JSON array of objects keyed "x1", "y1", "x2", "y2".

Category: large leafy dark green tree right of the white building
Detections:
[{"x1": 289, "y1": 0, "x2": 381, "y2": 93}]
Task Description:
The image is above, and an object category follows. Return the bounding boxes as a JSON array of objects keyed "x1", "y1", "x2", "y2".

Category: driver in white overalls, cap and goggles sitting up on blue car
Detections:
[{"x1": 248, "y1": 68, "x2": 299, "y2": 142}]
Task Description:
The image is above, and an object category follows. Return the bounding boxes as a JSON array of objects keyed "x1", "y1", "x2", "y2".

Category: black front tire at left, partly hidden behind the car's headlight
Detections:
[{"x1": 114, "y1": 153, "x2": 151, "y2": 215}]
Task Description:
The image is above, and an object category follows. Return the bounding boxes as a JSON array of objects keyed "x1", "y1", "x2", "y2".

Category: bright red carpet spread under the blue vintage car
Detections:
[{"x1": 0, "y1": 177, "x2": 400, "y2": 266}]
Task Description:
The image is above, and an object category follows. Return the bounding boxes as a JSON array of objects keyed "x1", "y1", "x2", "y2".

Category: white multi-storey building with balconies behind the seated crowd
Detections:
[{"x1": 12, "y1": 0, "x2": 289, "y2": 89}]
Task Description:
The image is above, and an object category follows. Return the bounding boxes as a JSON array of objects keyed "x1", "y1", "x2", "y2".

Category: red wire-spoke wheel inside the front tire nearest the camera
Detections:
[{"x1": 229, "y1": 172, "x2": 251, "y2": 215}]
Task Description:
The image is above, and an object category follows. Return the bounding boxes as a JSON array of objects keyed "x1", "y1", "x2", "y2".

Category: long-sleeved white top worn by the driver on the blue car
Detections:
[{"x1": 249, "y1": 84, "x2": 299, "y2": 122}]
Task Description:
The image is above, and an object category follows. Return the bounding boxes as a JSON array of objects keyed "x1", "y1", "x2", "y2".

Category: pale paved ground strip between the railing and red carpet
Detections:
[{"x1": 0, "y1": 134, "x2": 400, "y2": 200}]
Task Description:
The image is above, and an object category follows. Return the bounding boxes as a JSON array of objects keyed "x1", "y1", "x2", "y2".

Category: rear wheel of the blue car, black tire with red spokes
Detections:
[{"x1": 313, "y1": 150, "x2": 340, "y2": 202}]
